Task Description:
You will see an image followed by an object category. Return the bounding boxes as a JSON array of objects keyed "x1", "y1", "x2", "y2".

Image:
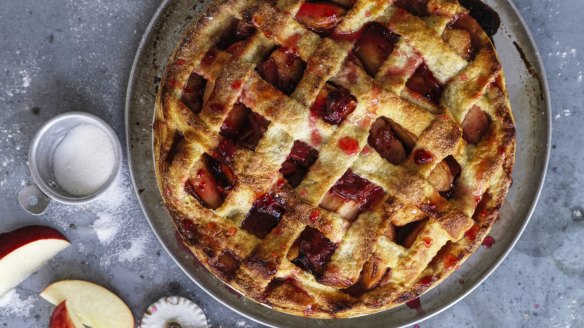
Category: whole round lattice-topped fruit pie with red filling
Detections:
[{"x1": 153, "y1": 0, "x2": 515, "y2": 318}]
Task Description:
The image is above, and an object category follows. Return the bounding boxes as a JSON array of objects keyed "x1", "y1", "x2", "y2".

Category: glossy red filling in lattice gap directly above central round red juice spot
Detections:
[{"x1": 310, "y1": 83, "x2": 357, "y2": 124}]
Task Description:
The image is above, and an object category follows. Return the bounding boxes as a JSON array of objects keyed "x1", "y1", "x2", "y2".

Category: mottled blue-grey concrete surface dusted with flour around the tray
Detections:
[{"x1": 0, "y1": 0, "x2": 584, "y2": 327}]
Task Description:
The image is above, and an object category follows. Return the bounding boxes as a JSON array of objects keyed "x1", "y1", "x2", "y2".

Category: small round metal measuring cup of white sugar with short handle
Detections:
[{"x1": 18, "y1": 112, "x2": 123, "y2": 214}]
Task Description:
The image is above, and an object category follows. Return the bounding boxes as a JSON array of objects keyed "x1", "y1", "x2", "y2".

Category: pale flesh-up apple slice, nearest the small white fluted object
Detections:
[{"x1": 41, "y1": 280, "x2": 134, "y2": 328}]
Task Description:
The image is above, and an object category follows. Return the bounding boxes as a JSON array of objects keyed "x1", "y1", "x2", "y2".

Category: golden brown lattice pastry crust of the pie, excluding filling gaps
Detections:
[{"x1": 153, "y1": 0, "x2": 515, "y2": 318}]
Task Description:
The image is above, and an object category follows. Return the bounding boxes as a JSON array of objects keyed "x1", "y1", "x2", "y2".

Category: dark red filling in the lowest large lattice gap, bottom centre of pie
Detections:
[{"x1": 287, "y1": 227, "x2": 337, "y2": 277}]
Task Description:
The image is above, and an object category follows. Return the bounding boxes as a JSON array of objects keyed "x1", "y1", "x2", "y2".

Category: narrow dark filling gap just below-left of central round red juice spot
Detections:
[{"x1": 280, "y1": 140, "x2": 318, "y2": 187}]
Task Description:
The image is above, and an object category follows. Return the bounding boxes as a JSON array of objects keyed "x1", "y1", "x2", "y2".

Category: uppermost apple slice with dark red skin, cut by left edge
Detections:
[{"x1": 0, "y1": 226, "x2": 70, "y2": 295}]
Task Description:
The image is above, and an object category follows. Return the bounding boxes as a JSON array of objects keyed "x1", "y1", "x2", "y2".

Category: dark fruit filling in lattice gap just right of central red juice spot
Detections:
[{"x1": 367, "y1": 118, "x2": 414, "y2": 165}]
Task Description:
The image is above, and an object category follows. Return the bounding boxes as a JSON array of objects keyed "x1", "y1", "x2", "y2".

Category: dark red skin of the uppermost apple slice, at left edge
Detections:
[{"x1": 0, "y1": 226, "x2": 68, "y2": 259}]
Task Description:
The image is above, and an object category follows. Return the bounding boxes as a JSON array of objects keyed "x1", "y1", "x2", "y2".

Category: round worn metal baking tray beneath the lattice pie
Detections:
[{"x1": 125, "y1": 0, "x2": 551, "y2": 327}]
